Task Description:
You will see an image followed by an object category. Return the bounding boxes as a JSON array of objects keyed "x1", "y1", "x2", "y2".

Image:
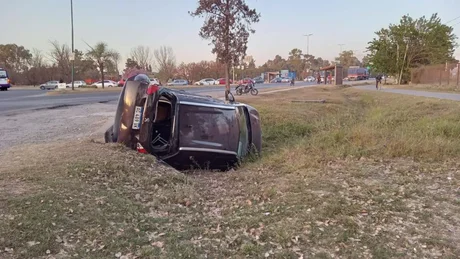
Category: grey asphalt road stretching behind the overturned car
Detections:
[{"x1": 0, "y1": 80, "x2": 372, "y2": 115}]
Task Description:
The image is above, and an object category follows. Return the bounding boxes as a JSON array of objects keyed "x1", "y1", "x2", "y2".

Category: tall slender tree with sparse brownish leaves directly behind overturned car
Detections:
[{"x1": 190, "y1": 0, "x2": 260, "y2": 100}]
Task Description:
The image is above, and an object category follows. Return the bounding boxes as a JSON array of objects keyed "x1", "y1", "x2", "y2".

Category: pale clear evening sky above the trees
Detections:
[{"x1": 0, "y1": 0, "x2": 460, "y2": 65}]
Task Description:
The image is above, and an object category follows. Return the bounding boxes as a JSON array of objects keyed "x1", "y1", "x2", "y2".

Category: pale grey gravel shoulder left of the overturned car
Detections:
[{"x1": 0, "y1": 102, "x2": 116, "y2": 152}]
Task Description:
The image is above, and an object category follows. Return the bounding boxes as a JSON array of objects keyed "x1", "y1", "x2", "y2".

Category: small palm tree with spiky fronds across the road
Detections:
[{"x1": 86, "y1": 42, "x2": 120, "y2": 89}]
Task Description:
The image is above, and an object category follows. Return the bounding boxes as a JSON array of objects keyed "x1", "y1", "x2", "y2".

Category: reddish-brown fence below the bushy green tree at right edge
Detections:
[{"x1": 411, "y1": 63, "x2": 460, "y2": 87}]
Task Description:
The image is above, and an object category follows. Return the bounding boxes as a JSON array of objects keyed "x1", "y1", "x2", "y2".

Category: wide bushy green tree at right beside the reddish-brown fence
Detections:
[{"x1": 367, "y1": 13, "x2": 457, "y2": 83}]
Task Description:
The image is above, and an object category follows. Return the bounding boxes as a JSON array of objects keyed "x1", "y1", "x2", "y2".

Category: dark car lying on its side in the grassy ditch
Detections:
[{"x1": 105, "y1": 74, "x2": 262, "y2": 170}]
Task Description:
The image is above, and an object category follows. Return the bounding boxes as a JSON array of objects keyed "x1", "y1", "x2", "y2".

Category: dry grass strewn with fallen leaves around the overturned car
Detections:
[{"x1": 0, "y1": 87, "x2": 460, "y2": 258}]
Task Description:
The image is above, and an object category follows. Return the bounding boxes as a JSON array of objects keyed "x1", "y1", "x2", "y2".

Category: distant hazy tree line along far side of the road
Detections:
[{"x1": 0, "y1": 41, "x2": 361, "y2": 85}]
